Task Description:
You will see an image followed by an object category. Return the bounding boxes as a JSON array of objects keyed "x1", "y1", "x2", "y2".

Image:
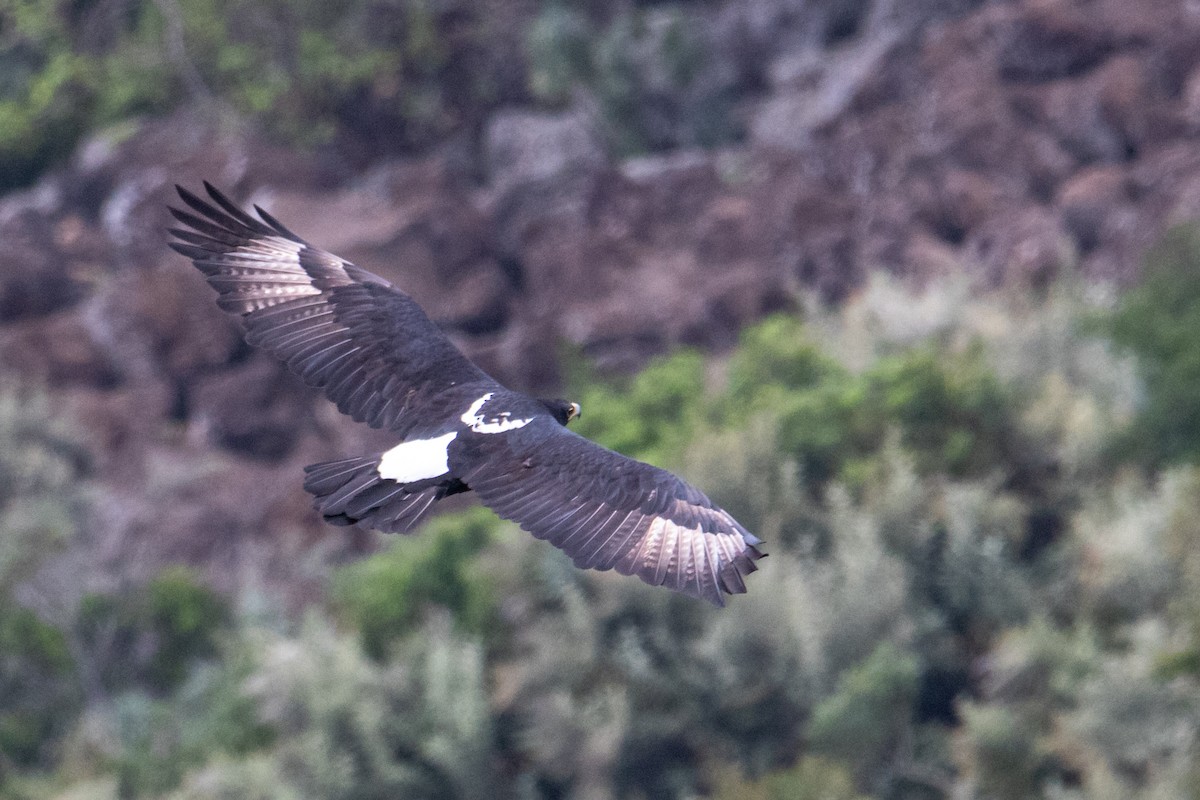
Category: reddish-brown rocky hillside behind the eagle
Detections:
[{"x1": 0, "y1": 0, "x2": 1200, "y2": 594}]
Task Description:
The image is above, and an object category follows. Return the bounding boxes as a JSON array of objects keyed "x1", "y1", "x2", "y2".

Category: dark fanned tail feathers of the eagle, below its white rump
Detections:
[{"x1": 304, "y1": 456, "x2": 467, "y2": 534}]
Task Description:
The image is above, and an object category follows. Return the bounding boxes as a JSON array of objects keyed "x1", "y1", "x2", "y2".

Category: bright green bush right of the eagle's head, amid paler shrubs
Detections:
[{"x1": 722, "y1": 317, "x2": 1019, "y2": 487}]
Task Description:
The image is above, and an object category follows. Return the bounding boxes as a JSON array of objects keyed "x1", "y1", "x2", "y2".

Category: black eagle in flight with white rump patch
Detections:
[{"x1": 170, "y1": 182, "x2": 763, "y2": 606}]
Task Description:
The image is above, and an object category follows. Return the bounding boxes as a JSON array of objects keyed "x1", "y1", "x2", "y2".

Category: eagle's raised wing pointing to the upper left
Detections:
[{"x1": 170, "y1": 182, "x2": 497, "y2": 435}]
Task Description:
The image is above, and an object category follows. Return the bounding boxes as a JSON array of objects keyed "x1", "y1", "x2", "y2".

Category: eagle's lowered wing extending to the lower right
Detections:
[{"x1": 450, "y1": 416, "x2": 763, "y2": 606}]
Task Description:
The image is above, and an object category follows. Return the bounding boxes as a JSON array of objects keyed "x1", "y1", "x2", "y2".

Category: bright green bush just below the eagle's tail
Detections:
[{"x1": 332, "y1": 509, "x2": 498, "y2": 660}]
